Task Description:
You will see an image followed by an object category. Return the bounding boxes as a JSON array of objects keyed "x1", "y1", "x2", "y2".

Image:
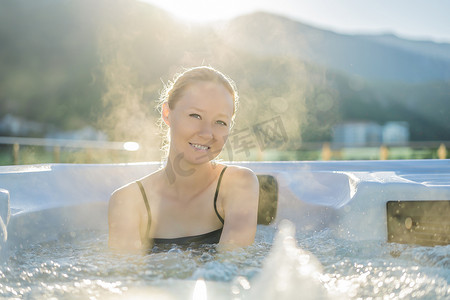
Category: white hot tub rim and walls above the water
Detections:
[{"x1": 0, "y1": 160, "x2": 450, "y2": 258}]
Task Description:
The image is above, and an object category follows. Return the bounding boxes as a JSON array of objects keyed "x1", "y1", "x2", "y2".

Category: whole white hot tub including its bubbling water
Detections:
[{"x1": 0, "y1": 160, "x2": 450, "y2": 299}]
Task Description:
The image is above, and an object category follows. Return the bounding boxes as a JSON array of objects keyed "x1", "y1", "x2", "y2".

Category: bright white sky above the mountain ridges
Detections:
[{"x1": 141, "y1": 0, "x2": 450, "y2": 43}]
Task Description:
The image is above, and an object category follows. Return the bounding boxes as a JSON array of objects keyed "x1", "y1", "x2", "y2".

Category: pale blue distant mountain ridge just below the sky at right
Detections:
[{"x1": 221, "y1": 12, "x2": 450, "y2": 83}]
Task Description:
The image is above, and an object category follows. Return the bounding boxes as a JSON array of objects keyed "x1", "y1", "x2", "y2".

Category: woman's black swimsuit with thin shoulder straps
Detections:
[{"x1": 136, "y1": 166, "x2": 227, "y2": 246}]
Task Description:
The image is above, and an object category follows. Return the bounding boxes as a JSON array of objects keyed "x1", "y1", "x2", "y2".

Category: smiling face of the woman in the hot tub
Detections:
[{"x1": 163, "y1": 82, "x2": 234, "y2": 164}]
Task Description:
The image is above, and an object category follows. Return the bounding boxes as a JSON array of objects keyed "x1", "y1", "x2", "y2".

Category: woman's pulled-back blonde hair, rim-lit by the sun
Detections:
[{"x1": 158, "y1": 66, "x2": 239, "y2": 158}]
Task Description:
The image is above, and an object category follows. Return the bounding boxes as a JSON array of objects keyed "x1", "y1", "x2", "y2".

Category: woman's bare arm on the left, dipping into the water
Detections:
[{"x1": 108, "y1": 184, "x2": 143, "y2": 252}]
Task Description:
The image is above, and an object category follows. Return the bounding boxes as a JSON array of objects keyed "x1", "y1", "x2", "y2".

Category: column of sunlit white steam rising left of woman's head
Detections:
[{"x1": 99, "y1": 4, "x2": 160, "y2": 161}]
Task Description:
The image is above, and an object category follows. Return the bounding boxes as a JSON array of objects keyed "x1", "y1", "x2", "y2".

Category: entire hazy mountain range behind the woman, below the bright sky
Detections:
[{"x1": 0, "y1": 0, "x2": 450, "y2": 149}]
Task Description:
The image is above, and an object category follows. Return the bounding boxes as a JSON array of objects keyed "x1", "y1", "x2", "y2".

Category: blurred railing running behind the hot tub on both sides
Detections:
[{"x1": 0, "y1": 137, "x2": 450, "y2": 164}]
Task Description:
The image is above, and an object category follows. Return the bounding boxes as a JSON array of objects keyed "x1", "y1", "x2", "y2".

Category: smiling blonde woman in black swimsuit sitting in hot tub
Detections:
[{"x1": 108, "y1": 67, "x2": 259, "y2": 252}]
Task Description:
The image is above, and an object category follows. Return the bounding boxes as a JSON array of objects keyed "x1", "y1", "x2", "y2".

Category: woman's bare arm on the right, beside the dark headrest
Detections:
[{"x1": 219, "y1": 167, "x2": 259, "y2": 250}]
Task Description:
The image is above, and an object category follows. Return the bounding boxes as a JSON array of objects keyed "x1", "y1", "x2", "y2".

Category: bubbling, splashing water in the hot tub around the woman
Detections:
[{"x1": 0, "y1": 222, "x2": 450, "y2": 299}]
